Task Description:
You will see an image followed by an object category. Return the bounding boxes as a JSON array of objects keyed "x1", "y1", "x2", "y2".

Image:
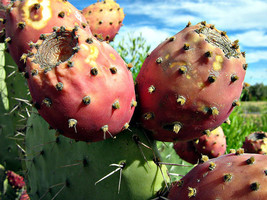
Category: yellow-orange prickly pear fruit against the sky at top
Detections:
[{"x1": 82, "y1": 0, "x2": 125, "y2": 41}]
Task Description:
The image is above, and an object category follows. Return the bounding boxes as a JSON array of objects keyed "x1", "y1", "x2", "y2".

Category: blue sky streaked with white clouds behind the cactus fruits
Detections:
[{"x1": 69, "y1": 0, "x2": 267, "y2": 85}]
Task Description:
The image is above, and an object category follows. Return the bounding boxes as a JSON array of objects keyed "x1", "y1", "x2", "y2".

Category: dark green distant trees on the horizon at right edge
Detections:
[{"x1": 241, "y1": 83, "x2": 267, "y2": 101}]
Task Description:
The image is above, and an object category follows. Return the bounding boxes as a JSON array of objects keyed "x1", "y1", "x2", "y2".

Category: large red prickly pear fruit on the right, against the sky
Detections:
[{"x1": 136, "y1": 22, "x2": 247, "y2": 142}]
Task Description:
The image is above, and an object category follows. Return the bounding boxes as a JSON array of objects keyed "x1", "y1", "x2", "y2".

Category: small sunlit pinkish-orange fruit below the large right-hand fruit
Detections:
[{"x1": 194, "y1": 126, "x2": 226, "y2": 158}]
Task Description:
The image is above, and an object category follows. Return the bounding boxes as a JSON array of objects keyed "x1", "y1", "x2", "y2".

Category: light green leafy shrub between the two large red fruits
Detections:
[{"x1": 113, "y1": 33, "x2": 151, "y2": 80}]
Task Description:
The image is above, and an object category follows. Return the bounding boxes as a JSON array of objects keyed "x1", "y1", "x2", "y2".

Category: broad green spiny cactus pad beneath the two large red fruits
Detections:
[{"x1": 26, "y1": 110, "x2": 168, "y2": 200}]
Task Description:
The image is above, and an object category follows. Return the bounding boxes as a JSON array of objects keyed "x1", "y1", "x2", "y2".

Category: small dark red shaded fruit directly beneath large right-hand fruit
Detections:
[{"x1": 173, "y1": 141, "x2": 201, "y2": 164}]
